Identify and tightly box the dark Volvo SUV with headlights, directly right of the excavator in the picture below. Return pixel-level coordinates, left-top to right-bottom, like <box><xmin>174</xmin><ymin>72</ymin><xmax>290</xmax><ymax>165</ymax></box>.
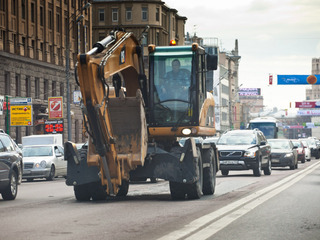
<box><xmin>217</xmin><ymin>129</ymin><xmax>271</xmax><ymax>176</ymax></box>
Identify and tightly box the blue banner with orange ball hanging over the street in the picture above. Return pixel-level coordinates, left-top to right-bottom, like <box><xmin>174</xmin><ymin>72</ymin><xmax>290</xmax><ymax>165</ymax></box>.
<box><xmin>278</xmin><ymin>74</ymin><xmax>320</xmax><ymax>85</ymax></box>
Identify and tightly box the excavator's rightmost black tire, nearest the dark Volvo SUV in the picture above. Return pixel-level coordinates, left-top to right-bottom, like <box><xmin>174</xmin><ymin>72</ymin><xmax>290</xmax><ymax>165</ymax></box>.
<box><xmin>202</xmin><ymin>148</ymin><xmax>217</xmax><ymax>195</ymax></box>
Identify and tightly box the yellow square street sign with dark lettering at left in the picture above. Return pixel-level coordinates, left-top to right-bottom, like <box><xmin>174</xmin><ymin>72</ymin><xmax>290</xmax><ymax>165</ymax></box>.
<box><xmin>10</xmin><ymin>105</ymin><xmax>33</xmax><ymax>126</ymax></box>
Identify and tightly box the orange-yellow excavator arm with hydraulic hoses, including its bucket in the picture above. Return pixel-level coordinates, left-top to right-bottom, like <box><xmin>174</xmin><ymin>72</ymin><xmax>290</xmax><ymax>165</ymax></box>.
<box><xmin>73</xmin><ymin>31</ymin><xmax>147</xmax><ymax>195</ymax></box>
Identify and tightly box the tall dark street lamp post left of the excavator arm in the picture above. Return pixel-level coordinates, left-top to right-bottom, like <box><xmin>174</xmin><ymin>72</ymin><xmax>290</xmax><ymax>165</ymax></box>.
<box><xmin>66</xmin><ymin>2</ymin><xmax>91</xmax><ymax>141</ymax></box>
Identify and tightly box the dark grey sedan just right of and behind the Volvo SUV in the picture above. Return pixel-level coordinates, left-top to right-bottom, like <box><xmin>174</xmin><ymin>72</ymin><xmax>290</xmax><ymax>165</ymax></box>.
<box><xmin>268</xmin><ymin>139</ymin><xmax>298</xmax><ymax>170</ymax></box>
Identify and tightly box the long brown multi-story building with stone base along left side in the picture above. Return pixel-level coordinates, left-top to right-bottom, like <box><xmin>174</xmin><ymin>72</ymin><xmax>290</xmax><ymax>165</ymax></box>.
<box><xmin>0</xmin><ymin>0</ymin><xmax>92</xmax><ymax>142</ymax></box>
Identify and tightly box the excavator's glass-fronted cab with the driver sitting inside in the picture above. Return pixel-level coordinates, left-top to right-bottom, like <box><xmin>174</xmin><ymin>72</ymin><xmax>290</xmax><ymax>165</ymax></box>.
<box><xmin>148</xmin><ymin>45</ymin><xmax>213</xmax><ymax>136</ymax></box>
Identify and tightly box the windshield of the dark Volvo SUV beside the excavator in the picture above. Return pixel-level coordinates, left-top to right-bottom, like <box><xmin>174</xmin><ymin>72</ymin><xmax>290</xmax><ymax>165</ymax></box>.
<box><xmin>217</xmin><ymin>134</ymin><xmax>256</xmax><ymax>145</ymax></box>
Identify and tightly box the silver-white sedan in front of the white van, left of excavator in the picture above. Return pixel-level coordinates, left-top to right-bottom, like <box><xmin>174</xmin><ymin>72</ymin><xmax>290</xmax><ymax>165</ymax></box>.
<box><xmin>22</xmin><ymin>145</ymin><xmax>67</xmax><ymax>181</ymax></box>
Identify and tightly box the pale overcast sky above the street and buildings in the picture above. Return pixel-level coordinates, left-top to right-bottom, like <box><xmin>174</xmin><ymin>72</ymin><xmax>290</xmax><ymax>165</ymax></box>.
<box><xmin>163</xmin><ymin>0</ymin><xmax>320</xmax><ymax>110</ymax></box>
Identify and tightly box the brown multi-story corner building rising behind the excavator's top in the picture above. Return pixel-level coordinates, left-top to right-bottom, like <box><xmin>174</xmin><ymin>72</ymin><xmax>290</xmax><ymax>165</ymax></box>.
<box><xmin>92</xmin><ymin>0</ymin><xmax>187</xmax><ymax>55</ymax></box>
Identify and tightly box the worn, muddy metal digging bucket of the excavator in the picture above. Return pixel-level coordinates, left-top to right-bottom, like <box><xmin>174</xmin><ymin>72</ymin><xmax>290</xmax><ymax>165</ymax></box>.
<box><xmin>108</xmin><ymin>90</ymin><xmax>148</xmax><ymax>170</ymax></box>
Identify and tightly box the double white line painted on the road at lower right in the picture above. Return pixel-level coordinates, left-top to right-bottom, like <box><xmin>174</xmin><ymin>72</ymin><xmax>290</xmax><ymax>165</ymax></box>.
<box><xmin>158</xmin><ymin>162</ymin><xmax>320</xmax><ymax>240</ymax></box>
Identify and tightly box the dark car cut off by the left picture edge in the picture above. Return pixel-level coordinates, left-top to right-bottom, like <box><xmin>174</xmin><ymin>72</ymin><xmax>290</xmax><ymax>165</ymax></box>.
<box><xmin>0</xmin><ymin>132</ymin><xmax>23</xmax><ymax>200</ymax></box>
